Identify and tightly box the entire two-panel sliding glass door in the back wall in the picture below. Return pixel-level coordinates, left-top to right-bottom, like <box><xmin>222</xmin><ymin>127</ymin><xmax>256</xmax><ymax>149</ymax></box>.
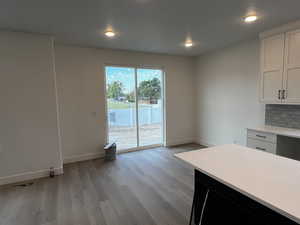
<box><xmin>105</xmin><ymin>66</ymin><xmax>164</xmax><ymax>151</ymax></box>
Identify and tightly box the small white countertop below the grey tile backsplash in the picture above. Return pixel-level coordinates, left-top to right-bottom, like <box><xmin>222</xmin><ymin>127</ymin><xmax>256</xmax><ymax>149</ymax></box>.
<box><xmin>248</xmin><ymin>126</ymin><xmax>300</xmax><ymax>138</ymax></box>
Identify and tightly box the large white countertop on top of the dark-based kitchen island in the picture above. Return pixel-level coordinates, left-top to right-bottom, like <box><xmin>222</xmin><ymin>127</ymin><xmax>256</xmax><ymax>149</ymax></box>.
<box><xmin>175</xmin><ymin>145</ymin><xmax>300</xmax><ymax>223</ymax></box>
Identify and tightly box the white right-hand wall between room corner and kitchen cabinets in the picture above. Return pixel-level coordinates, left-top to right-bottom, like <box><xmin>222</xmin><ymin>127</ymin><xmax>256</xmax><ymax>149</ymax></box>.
<box><xmin>197</xmin><ymin>40</ymin><xmax>264</xmax><ymax>145</ymax></box>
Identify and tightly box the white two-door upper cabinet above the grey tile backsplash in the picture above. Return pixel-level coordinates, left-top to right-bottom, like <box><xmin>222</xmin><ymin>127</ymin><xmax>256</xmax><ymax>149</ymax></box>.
<box><xmin>260</xmin><ymin>21</ymin><xmax>300</xmax><ymax>104</ymax></box>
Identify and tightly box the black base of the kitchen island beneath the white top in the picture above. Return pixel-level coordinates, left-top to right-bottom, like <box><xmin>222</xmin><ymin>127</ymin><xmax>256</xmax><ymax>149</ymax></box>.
<box><xmin>190</xmin><ymin>170</ymin><xmax>300</xmax><ymax>225</ymax></box>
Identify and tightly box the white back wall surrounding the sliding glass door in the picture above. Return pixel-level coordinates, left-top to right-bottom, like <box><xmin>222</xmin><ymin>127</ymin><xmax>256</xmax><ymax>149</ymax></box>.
<box><xmin>55</xmin><ymin>45</ymin><xmax>196</xmax><ymax>161</ymax></box>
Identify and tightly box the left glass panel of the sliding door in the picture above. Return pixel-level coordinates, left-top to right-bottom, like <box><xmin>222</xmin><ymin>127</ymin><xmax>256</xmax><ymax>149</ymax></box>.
<box><xmin>105</xmin><ymin>66</ymin><xmax>138</xmax><ymax>150</ymax></box>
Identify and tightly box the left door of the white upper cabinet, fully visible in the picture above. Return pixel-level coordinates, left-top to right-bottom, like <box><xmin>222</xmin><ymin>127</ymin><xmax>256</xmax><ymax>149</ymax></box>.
<box><xmin>261</xmin><ymin>34</ymin><xmax>284</xmax><ymax>103</ymax></box>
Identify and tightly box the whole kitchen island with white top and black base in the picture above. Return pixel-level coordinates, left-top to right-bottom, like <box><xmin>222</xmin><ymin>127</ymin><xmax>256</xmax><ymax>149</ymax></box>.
<box><xmin>175</xmin><ymin>145</ymin><xmax>300</xmax><ymax>225</ymax></box>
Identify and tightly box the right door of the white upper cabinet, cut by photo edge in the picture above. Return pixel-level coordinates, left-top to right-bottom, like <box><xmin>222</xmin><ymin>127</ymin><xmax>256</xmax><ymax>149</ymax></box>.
<box><xmin>283</xmin><ymin>30</ymin><xmax>300</xmax><ymax>103</ymax></box>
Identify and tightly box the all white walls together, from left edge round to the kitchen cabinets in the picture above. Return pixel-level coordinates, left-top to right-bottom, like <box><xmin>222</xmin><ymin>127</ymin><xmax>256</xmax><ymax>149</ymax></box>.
<box><xmin>0</xmin><ymin>32</ymin><xmax>264</xmax><ymax>184</ymax></box>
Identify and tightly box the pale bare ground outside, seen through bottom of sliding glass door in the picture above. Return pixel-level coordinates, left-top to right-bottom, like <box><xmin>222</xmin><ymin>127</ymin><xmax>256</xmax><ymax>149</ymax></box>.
<box><xmin>109</xmin><ymin>124</ymin><xmax>163</xmax><ymax>150</ymax></box>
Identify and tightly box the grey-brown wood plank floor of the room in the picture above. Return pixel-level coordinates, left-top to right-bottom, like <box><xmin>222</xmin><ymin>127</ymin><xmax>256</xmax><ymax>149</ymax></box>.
<box><xmin>0</xmin><ymin>145</ymin><xmax>201</xmax><ymax>225</ymax></box>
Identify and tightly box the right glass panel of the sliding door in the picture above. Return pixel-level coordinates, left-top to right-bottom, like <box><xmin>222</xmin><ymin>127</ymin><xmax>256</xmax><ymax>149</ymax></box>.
<box><xmin>137</xmin><ymin>69</ymin><xmax>163</xmax><ymax>146</ymax></box>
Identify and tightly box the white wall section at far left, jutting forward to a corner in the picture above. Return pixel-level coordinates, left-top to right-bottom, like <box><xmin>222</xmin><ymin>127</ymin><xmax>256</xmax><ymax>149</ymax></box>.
<box><xmin>0</xmin><ymin>32</ymin><xmax>62</xmax><ymax>184</ymax></box>
